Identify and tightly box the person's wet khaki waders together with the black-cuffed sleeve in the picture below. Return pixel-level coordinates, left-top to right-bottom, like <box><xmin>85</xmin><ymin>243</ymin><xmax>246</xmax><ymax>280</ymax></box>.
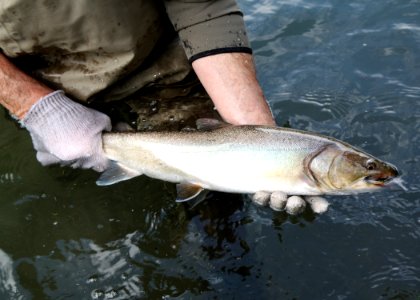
<box><xmin>0</xmin><ymin>0</ymin><xmax>250</xmax><ymax>101</ymax></box>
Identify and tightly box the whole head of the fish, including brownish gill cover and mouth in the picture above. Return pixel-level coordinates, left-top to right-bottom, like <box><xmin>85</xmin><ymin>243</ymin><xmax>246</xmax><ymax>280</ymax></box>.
<box><xmin>308</xmin><ymin>146</ymin><xmax>399</xmax><ymax>194</ymax></box>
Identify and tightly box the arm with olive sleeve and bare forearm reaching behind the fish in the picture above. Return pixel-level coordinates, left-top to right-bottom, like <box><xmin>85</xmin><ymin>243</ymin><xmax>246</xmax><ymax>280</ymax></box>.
<box><xmin>165</xmin><ymin>0</ymin><xmax>275</xmax><ymax>125</ymax></box>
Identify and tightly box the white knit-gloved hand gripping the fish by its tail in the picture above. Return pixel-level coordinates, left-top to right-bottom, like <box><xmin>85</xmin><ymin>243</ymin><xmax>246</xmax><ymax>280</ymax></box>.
<box><xmin>22</xmin><ymin>91</ymin><xmax>111</xmax><ymax>172</ymax></box>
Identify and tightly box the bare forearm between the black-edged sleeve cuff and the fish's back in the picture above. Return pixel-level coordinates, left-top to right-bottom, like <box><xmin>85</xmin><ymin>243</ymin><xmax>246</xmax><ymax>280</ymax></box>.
<box><xmin>192</xmin><ymin>53</ymin><xmax>275</xmax><ymax>125</ymax></box>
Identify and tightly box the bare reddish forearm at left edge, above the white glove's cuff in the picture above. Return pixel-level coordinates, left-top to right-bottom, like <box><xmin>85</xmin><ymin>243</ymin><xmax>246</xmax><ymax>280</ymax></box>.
<box><xmin>0</xmin><ymin>52</ymin><xmax>53</xmax><ymax>120</ymax></box>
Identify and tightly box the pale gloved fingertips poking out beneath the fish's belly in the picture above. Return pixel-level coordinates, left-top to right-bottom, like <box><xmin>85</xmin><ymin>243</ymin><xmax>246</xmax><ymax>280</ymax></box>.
<box><xmin>251</xmin><ymin>191</ymin><xmax>329</xmax><ymax>215</ymax></box>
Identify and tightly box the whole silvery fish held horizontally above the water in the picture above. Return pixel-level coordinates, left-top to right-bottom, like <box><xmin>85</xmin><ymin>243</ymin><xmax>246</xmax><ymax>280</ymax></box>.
<box><xmin>96</xmin><ymin>119</ymin><xmax>399</xmax><ymax>202</ymax></box>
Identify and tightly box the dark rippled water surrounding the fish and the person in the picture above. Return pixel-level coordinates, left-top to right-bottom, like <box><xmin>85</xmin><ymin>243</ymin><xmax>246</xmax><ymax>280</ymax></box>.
<box><xmin>0</xmin><ymin>0</ymin><xmax>420</xmax><ymax>299</ymax></box>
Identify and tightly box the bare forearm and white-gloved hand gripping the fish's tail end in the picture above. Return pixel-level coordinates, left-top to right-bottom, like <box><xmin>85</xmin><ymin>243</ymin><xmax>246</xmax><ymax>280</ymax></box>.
<box><xmin>0</xmin><ymin>53</ymin><xmax>111</xmax><ymax>171</ymax></box>
